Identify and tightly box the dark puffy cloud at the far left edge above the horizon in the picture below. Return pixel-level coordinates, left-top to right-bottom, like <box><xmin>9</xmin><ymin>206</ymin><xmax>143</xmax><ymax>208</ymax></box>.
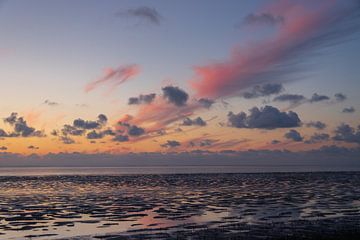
<box><xmin>1</xmin><ymin>112</ymin><xmax>45</xmax><ymax>137</ymax></box>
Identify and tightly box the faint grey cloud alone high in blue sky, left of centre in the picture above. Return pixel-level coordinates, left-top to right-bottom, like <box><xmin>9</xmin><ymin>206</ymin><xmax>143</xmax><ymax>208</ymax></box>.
<box><xmin>116</xmin><ymin>6</ymin><xmax>162</xmax><ymax>25</ymax></box>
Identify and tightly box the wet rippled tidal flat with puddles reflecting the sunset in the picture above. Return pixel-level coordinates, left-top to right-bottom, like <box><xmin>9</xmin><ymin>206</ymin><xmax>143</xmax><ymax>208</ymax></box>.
<box><xmin>0</xmin><ymin>172</ymin><xmax>360</xmax><ymax>240</ymax></box>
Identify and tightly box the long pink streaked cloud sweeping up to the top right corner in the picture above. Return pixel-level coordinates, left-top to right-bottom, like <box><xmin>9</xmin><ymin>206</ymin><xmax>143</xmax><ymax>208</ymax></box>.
<box><xmin>190</xmin><ymin>1</ymin><xmax>360</xmax><ymax>99</ymax></box>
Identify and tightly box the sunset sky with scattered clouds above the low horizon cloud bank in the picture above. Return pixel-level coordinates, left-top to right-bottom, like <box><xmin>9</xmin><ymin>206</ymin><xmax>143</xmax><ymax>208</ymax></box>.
<box><xmin>0</xmin><ymin>0</ymin><xmax>360</xmax><ymax>163</ymax></box>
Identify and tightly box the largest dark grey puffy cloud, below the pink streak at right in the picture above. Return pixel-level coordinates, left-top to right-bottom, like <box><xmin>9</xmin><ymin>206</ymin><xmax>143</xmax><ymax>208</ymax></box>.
<box><xmin>228</xmin><ymin>106</ymin><xmax>301</xmax><ymax>129</ymax></box>
